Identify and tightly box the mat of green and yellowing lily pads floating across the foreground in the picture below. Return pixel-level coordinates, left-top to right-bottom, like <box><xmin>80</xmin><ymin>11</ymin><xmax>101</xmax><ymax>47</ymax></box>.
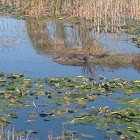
<box><xmin>0</xmin><ymin>72</ymin><xmax>140</xmax><ymax>139</ymax></box>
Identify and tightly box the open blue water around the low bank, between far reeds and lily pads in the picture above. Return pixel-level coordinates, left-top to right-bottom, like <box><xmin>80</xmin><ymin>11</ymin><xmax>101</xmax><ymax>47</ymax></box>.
<box><xmin>0</xmin><ymin>17</ymin><xmax>139</xmax><ymax>79</ymax></box>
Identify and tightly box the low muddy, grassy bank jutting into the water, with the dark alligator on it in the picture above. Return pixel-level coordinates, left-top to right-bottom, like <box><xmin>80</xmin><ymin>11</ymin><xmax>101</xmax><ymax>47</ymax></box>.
<box><xmin>53</xmin><ymin>53</ymin><xmax>140</xmax><ymax>70</ymax></box>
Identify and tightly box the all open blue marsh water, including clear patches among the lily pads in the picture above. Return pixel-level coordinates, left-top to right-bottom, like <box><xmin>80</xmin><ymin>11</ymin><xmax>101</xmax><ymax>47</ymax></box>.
<box><xmin>0</xmin><ymin>16</ymin><xmax>140</xmax><ymax>140</ymax></box>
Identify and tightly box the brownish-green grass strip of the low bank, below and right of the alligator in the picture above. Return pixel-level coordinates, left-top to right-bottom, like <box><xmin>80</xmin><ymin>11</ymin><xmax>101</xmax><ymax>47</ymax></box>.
<box><xmin>54</xmin><ymin>54</ymin><xmax>140</xmax><ymax>70</ymax></box>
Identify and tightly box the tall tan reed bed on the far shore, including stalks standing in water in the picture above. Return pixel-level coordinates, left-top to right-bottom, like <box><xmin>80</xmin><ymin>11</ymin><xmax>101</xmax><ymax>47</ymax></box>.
<box><xmin>0</xmin><ymin>0</ymin><xmax>140</xmax><ymax>34</ymax></box>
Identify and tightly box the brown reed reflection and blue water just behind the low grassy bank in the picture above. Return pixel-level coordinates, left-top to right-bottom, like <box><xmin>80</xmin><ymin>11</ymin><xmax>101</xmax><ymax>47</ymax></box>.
<box><xmin>26</xmin><ymin>20</ymin><xmax>140</xmax><ymax>54</ymax></box>
